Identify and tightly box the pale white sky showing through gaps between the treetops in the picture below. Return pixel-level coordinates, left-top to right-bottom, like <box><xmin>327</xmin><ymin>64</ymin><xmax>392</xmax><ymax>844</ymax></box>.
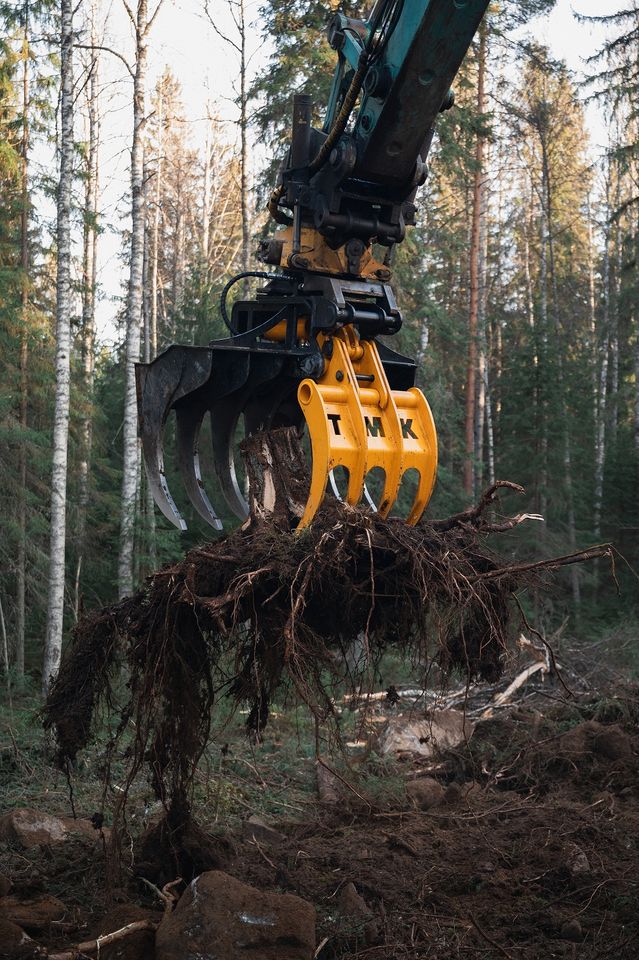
<box><xmin>90</xmin><ymin>0</ymin><xmax>624</xmax><ymax>341</ymax></box>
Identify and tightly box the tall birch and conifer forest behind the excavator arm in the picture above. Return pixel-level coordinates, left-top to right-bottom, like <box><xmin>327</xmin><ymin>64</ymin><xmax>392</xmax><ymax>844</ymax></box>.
<box><xmin>0</xmin><ymin>0</ymin><xmax>639</xmax><ymax>686</ymax></box>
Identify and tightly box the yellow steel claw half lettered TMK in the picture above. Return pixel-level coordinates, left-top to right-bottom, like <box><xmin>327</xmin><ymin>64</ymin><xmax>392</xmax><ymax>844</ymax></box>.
<box><xmin>297</xmin><ymin>326</ymin><xmax>437</xmax><ymax>529</ymax></box>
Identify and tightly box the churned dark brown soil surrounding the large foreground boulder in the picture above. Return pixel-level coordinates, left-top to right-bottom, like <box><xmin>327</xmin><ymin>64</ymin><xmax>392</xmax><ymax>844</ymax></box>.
<box><xmin>0</xmin><ymin>687</ymin><xmax>639</xmax><ymax>960</ymax></box>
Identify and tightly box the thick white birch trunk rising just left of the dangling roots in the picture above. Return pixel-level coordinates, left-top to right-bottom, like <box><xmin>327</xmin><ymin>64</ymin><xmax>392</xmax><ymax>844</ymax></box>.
<box><xmin>42</xmin><ymin>0</ymin><xmax>73</xmax><ymax>694</ymax></box>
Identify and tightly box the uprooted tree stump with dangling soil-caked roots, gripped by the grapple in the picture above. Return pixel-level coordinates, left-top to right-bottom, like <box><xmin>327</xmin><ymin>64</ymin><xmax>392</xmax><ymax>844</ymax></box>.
<box><xmin>44</xmin><ymin>430</ymin><xmax>608</xmax><ymax>834</ymax></box>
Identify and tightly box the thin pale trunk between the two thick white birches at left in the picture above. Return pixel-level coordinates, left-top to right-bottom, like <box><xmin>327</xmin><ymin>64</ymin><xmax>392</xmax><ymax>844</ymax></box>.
<box><xmin>74</xmin><ymin>30</ymin><xmax>100</xmax><ymax>620</ymax></box>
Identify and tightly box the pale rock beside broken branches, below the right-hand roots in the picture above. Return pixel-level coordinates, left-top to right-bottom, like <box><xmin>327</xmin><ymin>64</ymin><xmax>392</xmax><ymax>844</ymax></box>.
<box><xmin>376</xmin><ymin>710</ymin><xmax>475</xmax><ymax>757</ymax></box>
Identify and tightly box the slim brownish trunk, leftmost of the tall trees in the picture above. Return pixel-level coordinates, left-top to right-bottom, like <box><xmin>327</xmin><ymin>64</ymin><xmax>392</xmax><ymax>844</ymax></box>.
<box><xmin>14</xmin><ymin>11</ymin><xmax>30</xmax><ymax>683</ymax></box>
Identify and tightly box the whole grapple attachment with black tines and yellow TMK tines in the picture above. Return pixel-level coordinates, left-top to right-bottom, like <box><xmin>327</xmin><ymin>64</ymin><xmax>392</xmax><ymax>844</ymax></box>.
<box><xmin>136</xmin><ymin>277</ymin><xmax>437</xmax><ymax>530</ymax></box>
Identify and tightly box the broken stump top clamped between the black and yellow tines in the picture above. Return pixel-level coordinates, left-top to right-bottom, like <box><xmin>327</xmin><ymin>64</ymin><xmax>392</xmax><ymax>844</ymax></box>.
<box><xmin>240</xmin><ymin>427</ymin><xmax>310</xmax><ymax>531</ymax></box>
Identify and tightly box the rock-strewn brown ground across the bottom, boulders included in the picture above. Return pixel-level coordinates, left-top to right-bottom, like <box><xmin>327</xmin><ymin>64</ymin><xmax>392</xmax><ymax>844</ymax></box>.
<box><xmin>0</xmin><ymin>668</ymin><xmax>639</xmax><ymax>960</ymax></box>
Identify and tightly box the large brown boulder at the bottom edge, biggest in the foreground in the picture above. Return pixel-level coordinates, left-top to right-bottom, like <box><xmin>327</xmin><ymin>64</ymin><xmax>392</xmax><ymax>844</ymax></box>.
<box><xmin>155</xmin><ymin>870</ymin><xmax>315</xmax><ymax>960</ymax></box>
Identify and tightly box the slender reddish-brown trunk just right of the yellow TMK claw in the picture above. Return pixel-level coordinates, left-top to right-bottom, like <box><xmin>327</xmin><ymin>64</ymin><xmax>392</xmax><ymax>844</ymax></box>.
<box><xmin>464</xmin><ymin>23</ymin><xmax>486</xmax><ymax>497</ymax></box>
